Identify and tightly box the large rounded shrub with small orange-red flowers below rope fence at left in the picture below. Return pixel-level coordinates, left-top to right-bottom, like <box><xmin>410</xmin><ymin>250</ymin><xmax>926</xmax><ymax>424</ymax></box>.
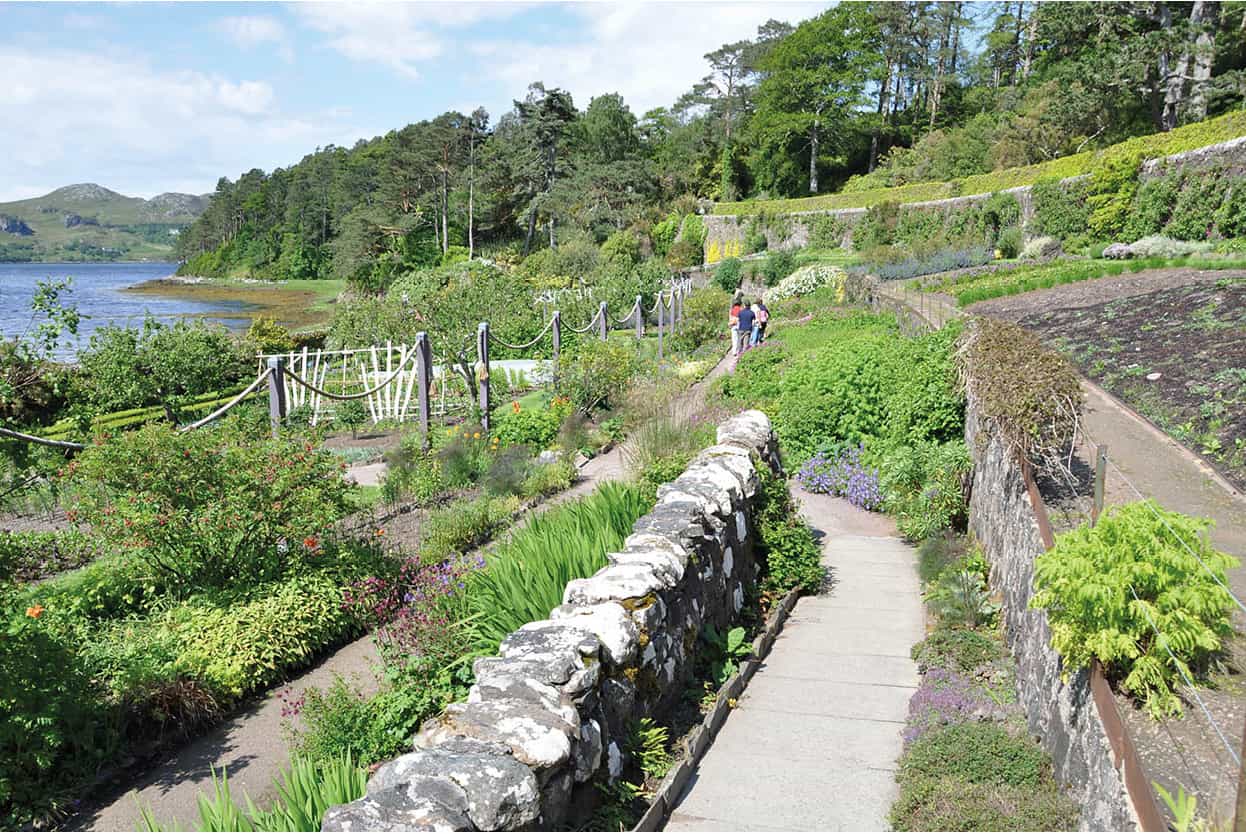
<box><xmin>66</xmin><ymin>423</ymin><xmax>350</xmax><ymax>592</ymax></box>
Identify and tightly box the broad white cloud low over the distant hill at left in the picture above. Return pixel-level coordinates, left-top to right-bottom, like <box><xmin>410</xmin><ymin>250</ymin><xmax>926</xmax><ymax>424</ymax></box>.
<box><xmin>0</xmin><ymin>45</ymin><xmax>361</xmax><ymax>198</ymax></box>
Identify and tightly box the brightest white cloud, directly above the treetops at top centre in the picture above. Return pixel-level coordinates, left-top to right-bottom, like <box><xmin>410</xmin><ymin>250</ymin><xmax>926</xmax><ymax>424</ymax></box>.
<box><xmin>473</xmin><ymin>0</ymin><xmax>831</xmax><ymax>115</ymax></box>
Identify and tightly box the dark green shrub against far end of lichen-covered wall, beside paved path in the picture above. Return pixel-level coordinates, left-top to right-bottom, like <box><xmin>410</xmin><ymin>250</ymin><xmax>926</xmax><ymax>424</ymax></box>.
<box><xmin>753</xmin><ymin>466</ymin><xmax>826</xmax><ymax>597</ymax></box>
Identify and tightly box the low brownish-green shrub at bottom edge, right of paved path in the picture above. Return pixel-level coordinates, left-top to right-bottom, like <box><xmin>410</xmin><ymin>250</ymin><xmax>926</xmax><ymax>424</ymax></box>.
<box><xmin>890</xmin><ymin>777</ymin><xmax>1078</xmax><ymax>832</ymax></box>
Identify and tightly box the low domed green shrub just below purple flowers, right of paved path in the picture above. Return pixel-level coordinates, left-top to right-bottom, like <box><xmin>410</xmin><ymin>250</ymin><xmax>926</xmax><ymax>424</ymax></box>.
<box><xmin>896</xmin><ymin>722</ymin><xmax>1052</xmax><ymax>788</ymax></box>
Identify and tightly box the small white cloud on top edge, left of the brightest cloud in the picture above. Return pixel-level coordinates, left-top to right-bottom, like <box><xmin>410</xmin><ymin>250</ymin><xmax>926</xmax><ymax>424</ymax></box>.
<box><xmin>294</xmin><ymin>2</ymin><xmax>526</xmax><ymax>80</ymax></box>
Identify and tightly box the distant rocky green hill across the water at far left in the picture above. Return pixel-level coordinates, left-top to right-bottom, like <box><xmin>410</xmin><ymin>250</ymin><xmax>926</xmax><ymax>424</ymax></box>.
<box><xmin>0</xmin><ymin>182</ymin><xmax>211</xmax><ymax>262</ymax></box>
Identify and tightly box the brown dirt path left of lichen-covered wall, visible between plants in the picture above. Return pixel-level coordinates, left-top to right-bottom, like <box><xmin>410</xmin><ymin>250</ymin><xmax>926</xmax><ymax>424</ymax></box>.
<box><xmin>75</xmin><ymin>357</ymin><xmax>735</xmax><ymax>832</ymax></box>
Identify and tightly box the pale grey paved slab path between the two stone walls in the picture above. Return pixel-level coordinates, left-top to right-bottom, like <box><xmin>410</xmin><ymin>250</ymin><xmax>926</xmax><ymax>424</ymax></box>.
<box><xmin>667</xmin><ymin>489</ymin><xmax>925</xmax><ymax>832</ymax></box>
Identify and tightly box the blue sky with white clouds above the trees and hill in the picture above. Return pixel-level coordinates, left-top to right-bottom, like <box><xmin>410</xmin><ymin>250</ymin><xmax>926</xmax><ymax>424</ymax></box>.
<box><xmin>0</xmin><ymin>0</ymin><xmax>831</xmax><ymax>202</ymax></box>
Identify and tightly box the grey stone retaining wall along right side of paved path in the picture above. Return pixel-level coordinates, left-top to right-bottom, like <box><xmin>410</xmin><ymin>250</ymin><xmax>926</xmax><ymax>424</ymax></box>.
<box><xmin>964</xmin><ymin>404</ymin><xmax>1139</xmax><ymax>832</ymax></box>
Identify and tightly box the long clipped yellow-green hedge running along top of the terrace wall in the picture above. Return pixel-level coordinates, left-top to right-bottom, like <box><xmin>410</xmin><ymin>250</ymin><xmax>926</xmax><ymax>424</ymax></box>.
<box><xmin>714</xmin><ymin>112</ymin><xmax>1246</xmax><ymax>214</ymax></box>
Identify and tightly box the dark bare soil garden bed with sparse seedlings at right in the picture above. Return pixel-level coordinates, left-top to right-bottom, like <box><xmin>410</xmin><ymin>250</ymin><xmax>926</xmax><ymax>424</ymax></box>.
<box><xmin>971</xmin><ymin>269</ymin><xmax>1246</xmax><ymax>490</ymax></box>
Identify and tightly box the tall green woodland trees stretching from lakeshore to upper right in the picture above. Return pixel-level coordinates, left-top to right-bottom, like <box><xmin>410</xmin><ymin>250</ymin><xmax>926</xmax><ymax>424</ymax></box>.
<box><xmin>178</xmin><ymin>0</ymin><xmax>1246</xmax><ymax>289</ymax></box>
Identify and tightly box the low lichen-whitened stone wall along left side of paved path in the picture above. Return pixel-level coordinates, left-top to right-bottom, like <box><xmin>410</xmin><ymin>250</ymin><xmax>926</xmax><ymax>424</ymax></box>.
<box><xmin>323</xmin><ymin>411</ymin><xmax>779</xmax><ymax>832</ymax></box>
